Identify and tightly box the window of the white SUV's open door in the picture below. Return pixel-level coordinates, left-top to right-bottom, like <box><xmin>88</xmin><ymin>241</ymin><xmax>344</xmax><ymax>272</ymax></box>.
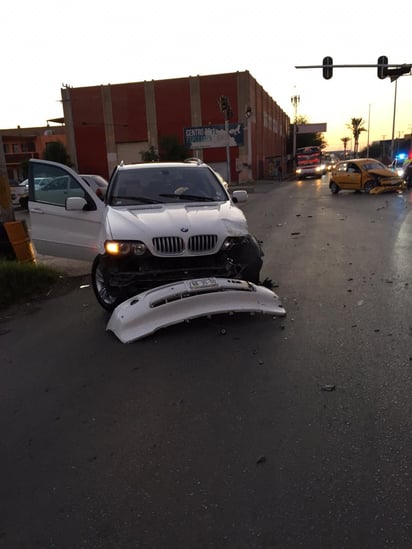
<box><xmin>32</xmin><ymin>164</ymin><xmax>88</xmax><ymax>208</ymax></box>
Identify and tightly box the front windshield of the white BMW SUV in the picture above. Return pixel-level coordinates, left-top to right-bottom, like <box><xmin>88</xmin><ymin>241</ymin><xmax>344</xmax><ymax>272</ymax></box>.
<box><xmin>108</xmin><ymin>166</ymin><xmax>228</xmax><ymax>206</ymax></box>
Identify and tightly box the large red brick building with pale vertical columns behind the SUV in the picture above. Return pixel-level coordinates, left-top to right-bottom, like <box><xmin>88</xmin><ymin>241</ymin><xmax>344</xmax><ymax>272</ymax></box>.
<box><xmin>61</xmin><ymin>71</ymin><xmax>290</xmax><ymax>182</ymax></box>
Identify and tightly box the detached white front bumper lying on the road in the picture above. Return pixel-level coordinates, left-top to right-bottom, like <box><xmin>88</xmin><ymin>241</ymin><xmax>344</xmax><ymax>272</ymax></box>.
<box><xmin>106</xmin><ymin>278</ymin><xmax>286</xmax><ymax>343</ymax></box>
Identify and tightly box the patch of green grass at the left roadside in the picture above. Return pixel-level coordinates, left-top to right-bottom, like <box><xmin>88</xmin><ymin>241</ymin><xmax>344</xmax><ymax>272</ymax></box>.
<box><xmin>0</xmin><ymin>260</ymin><xmax>60</xmax><ymax>307</ymax></box>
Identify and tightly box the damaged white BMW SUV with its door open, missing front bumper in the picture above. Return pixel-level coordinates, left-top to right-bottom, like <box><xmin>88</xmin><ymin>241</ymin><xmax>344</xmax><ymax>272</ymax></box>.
<box><xmin>29</xmin><ymin>160</ymin><xmax>263</xmax><ymax>311</ymax></box>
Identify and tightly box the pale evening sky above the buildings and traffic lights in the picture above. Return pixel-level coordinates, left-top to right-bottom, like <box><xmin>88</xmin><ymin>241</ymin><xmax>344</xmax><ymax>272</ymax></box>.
<box><xmin>0</xmin><ymin>0</ymin><xmax>412</xmax><ymax>150</ymax></box>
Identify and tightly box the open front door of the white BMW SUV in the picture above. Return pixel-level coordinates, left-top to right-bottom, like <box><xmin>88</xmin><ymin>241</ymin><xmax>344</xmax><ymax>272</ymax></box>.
<box><xmin>29</xmin><ymin>160</ymin><xmax>105</xmax><ymax>261</ymax></box>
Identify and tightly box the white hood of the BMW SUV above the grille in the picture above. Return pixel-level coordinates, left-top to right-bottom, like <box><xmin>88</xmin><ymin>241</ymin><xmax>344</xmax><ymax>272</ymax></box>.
<box><xmin>105</xmin><ymin>202</ymin><xmax>248</xmax><ymax>241</ymax></box>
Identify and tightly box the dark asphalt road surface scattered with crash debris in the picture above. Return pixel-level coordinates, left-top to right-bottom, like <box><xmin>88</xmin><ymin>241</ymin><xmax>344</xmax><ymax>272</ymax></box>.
<box><xmin>0</xmin><ymin>180</ymin><xmax>412</xmax><ymax>549</ymax></box>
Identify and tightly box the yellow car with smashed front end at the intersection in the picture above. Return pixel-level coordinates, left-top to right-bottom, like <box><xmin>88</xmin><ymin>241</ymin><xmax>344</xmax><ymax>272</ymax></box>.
<box><xmin>329</xmin><ymin>158</ymin><xmax>406</xmax><ymax>194</ymax></box>
